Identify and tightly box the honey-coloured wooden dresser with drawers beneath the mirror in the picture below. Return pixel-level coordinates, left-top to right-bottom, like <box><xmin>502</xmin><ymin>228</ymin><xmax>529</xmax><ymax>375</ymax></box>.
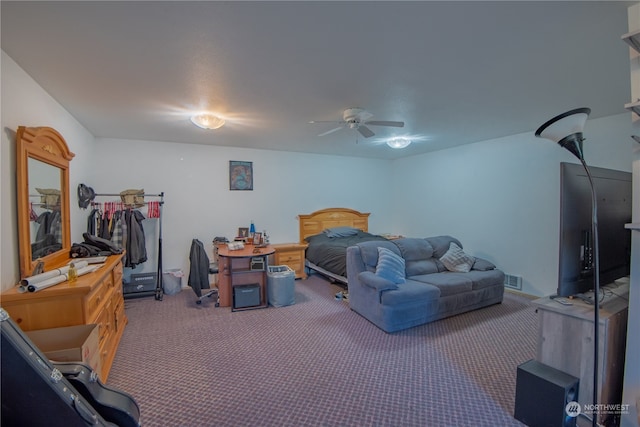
<box><xmin>0</xmin><ymin>255</ymin><xmax>127</xmax><ymax>382</ymax></box>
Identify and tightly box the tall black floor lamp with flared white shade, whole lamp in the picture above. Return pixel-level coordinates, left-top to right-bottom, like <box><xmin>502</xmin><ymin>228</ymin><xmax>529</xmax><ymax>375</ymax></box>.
<box><xmin>536</xmin><ymin>108</ymin><xmax>600</xmax><ymax>427</ymax></box>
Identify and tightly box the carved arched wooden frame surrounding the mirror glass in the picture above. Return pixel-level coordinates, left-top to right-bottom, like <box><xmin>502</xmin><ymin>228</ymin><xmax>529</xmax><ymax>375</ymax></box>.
<box><xmin>16</xmin><ymin>126</ymin><xmax>75</xmax><ymax>278</ymax></box>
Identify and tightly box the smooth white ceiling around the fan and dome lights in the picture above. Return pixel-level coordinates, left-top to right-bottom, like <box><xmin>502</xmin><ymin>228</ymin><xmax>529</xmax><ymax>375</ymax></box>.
<box><xmin>0</xmin><ymin>1</ymin><xmax>634</xmax><ymax>159</ymax></box>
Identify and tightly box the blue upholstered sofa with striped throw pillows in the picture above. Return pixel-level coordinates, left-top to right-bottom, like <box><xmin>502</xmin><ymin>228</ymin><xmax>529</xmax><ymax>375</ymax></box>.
<box><xmin>347</xmin><ymin>236</ymin><xmax>504</xmax><ymax>333</ymax></box>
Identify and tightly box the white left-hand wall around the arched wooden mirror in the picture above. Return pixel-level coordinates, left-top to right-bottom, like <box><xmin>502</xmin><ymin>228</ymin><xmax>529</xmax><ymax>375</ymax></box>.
<box><xmin>0</xmin><ymin>51</ymin><xmax>94</xmax><ymax>289</ymax></box>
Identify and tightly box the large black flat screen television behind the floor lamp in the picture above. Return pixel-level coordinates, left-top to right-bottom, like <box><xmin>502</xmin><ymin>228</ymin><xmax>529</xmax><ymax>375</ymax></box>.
<box><xmin>558</xmin><ymin>163</ymin><xmax>632</xmax><ymax>297</ymax></box>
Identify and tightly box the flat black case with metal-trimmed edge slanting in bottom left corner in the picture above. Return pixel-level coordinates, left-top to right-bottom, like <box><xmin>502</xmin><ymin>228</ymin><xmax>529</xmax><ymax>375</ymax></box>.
<box><xmin>0</xmin><ymin>308</ymin><xmax>115</xmax><ymax>427</ymax></box>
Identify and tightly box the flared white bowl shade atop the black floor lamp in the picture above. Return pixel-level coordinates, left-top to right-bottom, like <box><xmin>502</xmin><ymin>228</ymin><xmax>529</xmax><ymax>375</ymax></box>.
<box><xmin>536</xmin><ymin>108</ymin><xmax>591</xmax><ymax>158</ymax></box>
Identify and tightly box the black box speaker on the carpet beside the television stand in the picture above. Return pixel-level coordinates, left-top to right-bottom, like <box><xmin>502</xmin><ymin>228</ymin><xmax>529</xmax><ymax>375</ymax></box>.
<box><xmin>514</xmin><ymin>360</ymin><xmax>580</xmax><ymax>427</ymax></box>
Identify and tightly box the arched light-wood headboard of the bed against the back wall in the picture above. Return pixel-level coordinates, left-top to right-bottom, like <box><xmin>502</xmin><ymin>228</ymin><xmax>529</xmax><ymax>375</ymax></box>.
<box><xmin>298</xmin><ymin>208</ymin><xmax>370</xmax><ymax>243</ymax></box>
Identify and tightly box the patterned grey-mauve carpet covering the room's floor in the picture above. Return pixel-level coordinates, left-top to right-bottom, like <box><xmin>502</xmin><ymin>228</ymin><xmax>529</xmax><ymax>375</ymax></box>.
<box><xmin>108</xmin><ymin>275</ymin><xmax>537</xmax><ymax>427</ymax></box>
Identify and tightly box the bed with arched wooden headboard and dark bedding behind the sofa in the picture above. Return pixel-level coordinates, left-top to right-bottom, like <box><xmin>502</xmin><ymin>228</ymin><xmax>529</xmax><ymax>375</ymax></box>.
<box><xmin>298</xmin><ymin>208</ymin><xmax>387</xmax><ymax>285</ymax></box>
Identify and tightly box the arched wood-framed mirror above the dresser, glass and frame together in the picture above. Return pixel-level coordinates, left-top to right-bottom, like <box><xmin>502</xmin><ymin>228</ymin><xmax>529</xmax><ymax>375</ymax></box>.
<box><xmin>16</xmin><ymin>126</ymin><xmax>74</xmax><ymax>278</ymax></box>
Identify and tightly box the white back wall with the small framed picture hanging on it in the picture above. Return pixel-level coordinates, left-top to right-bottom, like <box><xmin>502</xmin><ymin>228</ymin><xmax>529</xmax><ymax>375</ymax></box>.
<box><xmin>86</xmin><ymin>139</ymin><xmax>393</xmax><ymax>284</ymax></box>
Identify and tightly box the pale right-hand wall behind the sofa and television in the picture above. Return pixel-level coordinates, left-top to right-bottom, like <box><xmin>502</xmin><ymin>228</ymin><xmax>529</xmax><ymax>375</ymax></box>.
<box><xmin>392</xmin><ymin>115</ymin><xmax>635</xmax><ymax>296</ymax></box>
